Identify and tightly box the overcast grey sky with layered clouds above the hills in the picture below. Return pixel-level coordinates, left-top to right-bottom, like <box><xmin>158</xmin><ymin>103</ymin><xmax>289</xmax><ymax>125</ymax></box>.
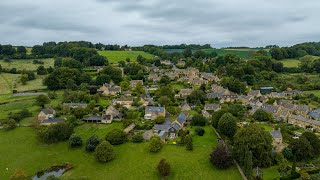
<box><xmin>0</xmin><ymin>0</ymin><xmax>320</xmax><ymax>47</ymax></box>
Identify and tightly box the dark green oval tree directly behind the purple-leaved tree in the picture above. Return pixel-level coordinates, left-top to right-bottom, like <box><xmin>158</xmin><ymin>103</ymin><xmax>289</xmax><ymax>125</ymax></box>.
<box><xmin>218</xmin><ymin>113</ymin><xmax>237</xmax><ymax>138</ymax></box>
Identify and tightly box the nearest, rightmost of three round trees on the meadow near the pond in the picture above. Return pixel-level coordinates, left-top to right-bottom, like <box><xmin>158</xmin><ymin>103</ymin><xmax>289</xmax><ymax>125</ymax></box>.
<box><xmin>94</xmin><ymin>141</ymin><xmax>115</xmax><ymax>163</ymax></box>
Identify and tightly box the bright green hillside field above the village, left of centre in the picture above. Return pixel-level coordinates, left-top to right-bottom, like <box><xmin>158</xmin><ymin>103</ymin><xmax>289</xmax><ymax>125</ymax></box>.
<box><xmin>98</xmin><ymin>51</ymin><xmax>154</xmax><ymax>63</ymax></box>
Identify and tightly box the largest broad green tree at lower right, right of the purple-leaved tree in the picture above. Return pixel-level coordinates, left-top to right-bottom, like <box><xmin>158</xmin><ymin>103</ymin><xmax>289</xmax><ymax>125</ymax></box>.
<box><xmin>233</xmin><ymin>124</ymin><xmax>272</xmax><ymax>167</ymax></box>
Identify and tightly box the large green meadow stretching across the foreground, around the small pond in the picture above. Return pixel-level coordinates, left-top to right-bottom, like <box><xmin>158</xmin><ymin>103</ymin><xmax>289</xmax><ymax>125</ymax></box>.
<box><xmin>0</xmin><ymin>123</ymin><xmax>241</xmax><ymax>180</ymax></box>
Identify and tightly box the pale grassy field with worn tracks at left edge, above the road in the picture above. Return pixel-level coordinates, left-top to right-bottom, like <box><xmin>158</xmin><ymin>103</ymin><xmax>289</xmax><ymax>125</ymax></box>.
<box><xmin>0</xmin><ymin>73</ymin><xmax>46</xmax><ymax>95</ymax></box>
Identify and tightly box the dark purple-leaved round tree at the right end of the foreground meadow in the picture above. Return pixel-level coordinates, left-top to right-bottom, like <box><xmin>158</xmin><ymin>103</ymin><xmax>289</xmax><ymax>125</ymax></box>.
<box><xmin>210</xmin><ymin>144</ymin><xmax>233</xmax><ymax>169</ymax></box>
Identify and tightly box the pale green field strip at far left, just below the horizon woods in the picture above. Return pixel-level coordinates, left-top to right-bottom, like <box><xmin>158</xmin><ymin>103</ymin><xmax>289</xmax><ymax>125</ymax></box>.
<box><xmin>0</xmin><ymin>58</ymin><xmax>54</xmax><ymax>71</ymax></box>
